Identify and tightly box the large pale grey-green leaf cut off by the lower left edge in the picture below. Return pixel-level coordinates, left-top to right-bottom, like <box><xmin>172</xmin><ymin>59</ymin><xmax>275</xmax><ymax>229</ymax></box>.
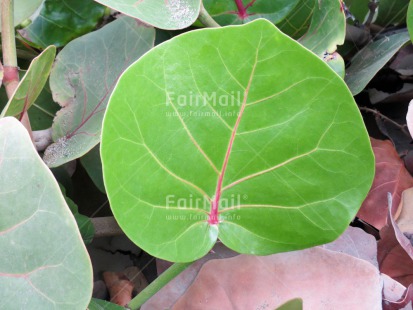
<box><xmin>0</xmin><ymin>117</ymin><xmax>92</xmax><ymax>310</ymax></box>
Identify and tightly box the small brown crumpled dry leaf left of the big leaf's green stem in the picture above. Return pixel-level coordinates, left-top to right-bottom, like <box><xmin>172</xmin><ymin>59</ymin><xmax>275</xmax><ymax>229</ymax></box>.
<box><xmin>103</xmin><ymin>271</ymin><xmax>134</xmax><ymax>306</ymax></box>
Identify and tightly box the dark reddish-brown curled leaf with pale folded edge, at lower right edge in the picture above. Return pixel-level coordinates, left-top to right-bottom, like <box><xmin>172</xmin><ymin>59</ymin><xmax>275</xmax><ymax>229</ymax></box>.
<box><xmin>377</xmin><ymin>202</ymin><xmax>413</xmax><ymax>286</ymax></box>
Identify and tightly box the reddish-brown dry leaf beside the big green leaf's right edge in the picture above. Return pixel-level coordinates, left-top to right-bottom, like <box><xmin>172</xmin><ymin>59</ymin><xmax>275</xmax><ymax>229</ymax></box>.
<box><xmin>357</xmin><ymin>138</ymin><xmax>413</xmax><ymax>229</ymax></box>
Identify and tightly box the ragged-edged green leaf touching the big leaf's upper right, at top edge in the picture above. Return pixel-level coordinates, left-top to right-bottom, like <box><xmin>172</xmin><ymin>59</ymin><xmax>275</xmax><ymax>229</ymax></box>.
<box><xmin>300</xmin><ymin>0</ymin><xmax>346</xmax><ymax>57</ymax></box>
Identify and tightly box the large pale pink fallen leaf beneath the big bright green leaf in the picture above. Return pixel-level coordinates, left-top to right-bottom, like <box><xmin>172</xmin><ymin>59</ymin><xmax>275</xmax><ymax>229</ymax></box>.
<box><xmin>173</xmin><ymin>247</ymin><xmax>382</xmax><ymax>310</ymax></box>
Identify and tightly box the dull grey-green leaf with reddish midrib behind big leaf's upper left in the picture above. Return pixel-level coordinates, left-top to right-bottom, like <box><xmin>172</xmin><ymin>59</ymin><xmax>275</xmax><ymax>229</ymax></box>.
<box><xmin>43</xmin><ymin>17</ymin><xmax>155</xmax><ymax>167</ymax></box>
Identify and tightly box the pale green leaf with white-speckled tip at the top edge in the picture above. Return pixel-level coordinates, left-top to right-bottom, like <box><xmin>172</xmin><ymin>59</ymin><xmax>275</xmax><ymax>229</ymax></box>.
<box><xmin>95</xmin><ymin>0</ymin><xmax>201</xmax><ymax>30</ymax></box>
